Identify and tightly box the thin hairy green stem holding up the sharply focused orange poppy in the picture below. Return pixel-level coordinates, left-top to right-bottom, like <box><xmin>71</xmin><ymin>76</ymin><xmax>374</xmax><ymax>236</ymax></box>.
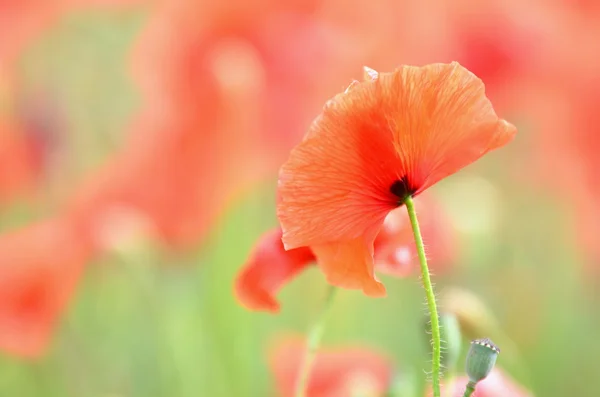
<box><xmin>404</xmin><ymin>196</ymin><xmax>441</xmax><ymax>397</ymax></box>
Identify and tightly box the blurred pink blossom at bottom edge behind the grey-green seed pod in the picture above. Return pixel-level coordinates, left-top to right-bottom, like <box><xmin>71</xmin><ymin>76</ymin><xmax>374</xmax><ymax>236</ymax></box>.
<box><xmin>427</xmin><ymin>368</ymin><xmax>533</xmax><ymax>397</ymax></box>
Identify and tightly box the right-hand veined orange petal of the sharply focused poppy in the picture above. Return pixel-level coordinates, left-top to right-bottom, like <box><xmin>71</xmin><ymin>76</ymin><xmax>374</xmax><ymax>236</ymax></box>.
<box><xmin>386</xmin><ymin>62</ymin><xmax>517</xmax><ymax>194</ymax></box>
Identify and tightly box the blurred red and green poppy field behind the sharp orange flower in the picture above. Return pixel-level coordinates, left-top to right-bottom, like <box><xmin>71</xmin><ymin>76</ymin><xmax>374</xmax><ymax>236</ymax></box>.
<box><xmin>0</xmin><ymin>0</ymin><xmax>600</xmax><ymax>397</ymax></box>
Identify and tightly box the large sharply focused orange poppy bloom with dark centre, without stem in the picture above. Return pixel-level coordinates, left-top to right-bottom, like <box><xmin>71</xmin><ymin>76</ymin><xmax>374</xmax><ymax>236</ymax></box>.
<box><xmin>277</xmin><ymin>63</ymin><xmax>516</xmax><ymax>296</ymax></box>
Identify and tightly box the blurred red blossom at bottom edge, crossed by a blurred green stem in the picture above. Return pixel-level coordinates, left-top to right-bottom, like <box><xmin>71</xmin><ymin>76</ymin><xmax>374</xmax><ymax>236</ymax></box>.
<box><xmin>269</xmin><ymin>338</ymin><xmax>393</xmax><ymax>397</ymax></box>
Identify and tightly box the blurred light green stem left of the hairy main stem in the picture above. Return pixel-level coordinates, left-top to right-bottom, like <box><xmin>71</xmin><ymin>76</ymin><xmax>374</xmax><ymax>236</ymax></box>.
<box><xmin>294</xmin><ymin>285</ymin><xmax>337</xmax><ymax>397</ymax></box>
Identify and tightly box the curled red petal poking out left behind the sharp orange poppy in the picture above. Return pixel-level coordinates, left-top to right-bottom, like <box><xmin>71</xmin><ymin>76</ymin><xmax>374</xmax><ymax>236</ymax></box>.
<box><xmin>235</xmin><ymin>228</ymin><xmax>315</xmax><ymax>313</ymax></box>
